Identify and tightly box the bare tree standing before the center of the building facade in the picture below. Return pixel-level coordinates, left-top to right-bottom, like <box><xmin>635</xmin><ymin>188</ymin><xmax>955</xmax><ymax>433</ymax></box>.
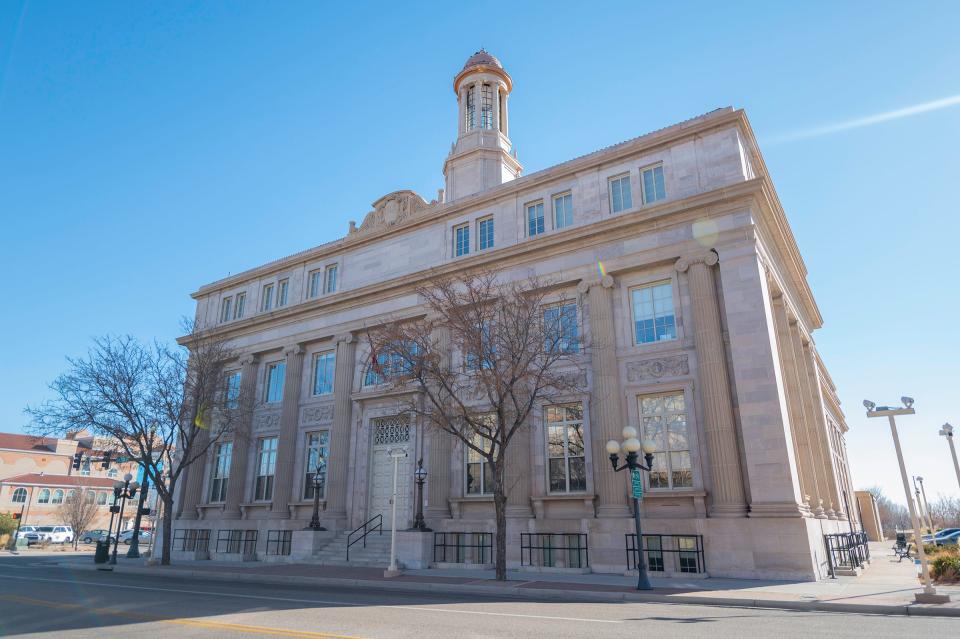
<box><xmin>367</xmin><ymin>271</ymin><xmax>585</xmax><ymax>580</ymax></box>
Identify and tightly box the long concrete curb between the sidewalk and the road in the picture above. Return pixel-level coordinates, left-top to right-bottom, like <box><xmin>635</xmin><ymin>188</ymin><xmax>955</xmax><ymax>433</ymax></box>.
<box><xmin>57</xmin><ymin>563</ymin><xmax>960</xmax><ymax>617</ymax></box>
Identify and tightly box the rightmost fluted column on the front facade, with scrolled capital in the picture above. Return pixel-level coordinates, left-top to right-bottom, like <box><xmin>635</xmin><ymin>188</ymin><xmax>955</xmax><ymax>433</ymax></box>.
<box><xmin>677</xmin><ymin>251</ymin><xmax>746</xmax><ymax>517</ymax></box>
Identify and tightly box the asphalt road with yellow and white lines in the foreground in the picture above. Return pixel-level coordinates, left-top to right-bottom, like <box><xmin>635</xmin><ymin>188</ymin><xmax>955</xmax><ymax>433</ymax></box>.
<box><xmin>0</xmin><ymin>553</ymin><xmax>960</xmax><ymax>639</ymax></box>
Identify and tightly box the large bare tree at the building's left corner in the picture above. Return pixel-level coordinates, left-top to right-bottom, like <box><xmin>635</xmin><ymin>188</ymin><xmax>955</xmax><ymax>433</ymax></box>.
<box><xmin>26</xmin><ymin>326</ymin><xmax>248</xmax><ymax>565</ymax></box>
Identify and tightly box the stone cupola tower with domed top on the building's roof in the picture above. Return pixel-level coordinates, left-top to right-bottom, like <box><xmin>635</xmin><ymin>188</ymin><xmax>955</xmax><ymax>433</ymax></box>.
<box><xmin>443</xmin><ymin>49</ymin><xmax>523</xmax><ymax>202</ymax></box>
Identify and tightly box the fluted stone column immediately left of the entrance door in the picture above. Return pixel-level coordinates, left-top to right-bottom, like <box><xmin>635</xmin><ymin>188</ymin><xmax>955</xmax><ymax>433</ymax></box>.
<box><xmin>327</xmin><ymin>333</ymin><xmax>357</xmax><ymax>519</ymax></box>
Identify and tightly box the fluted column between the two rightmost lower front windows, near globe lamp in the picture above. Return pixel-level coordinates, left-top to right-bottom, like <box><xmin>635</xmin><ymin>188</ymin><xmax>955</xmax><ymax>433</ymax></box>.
<box><xmin>577</xmin><ymin>275</ymin><xmax>630</xmax><ymax>517</ymax></box>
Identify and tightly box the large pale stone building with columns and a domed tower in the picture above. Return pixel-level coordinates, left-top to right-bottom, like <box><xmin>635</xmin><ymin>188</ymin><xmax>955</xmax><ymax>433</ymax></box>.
<box><xmin>174</xmin><ymin>51</ymin><xmax>853</xmax><ymax>579</ymax></box>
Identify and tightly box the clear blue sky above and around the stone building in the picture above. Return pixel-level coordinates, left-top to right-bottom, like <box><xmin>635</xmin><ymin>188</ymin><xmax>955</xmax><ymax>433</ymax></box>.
<box><xmin>0</xmin><ymin>0</ymin><xmax>960</xmax><ymax>508</ymax></box>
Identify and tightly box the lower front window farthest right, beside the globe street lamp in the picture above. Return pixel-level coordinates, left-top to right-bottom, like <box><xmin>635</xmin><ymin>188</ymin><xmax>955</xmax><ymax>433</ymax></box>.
<box><xmin>638</xmin><ymin>391</ymin><xmax>693</xmax><ymax>488</ymax></box>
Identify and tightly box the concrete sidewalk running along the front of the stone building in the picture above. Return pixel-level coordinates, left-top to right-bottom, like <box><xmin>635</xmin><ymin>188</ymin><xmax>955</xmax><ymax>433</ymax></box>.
<box><xmin>59</xmin><ymin>545</ymin><xmax>960</xmax><ymax>617</ymax></box>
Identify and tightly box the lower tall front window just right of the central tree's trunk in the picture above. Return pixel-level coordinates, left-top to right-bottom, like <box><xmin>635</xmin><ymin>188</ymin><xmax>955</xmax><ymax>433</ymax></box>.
<box><xmin>545</xmin><ymin>402</ymin><xmax>587</xmax><ymax>493</ymax></box>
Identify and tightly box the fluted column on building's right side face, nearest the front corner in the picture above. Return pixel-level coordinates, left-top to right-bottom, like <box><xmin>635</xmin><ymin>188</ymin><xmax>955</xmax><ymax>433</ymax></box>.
<box><xmin>771</xmin><ymin>294</ymin><xmax>817</xmax><ymax>509</ymax></box>
